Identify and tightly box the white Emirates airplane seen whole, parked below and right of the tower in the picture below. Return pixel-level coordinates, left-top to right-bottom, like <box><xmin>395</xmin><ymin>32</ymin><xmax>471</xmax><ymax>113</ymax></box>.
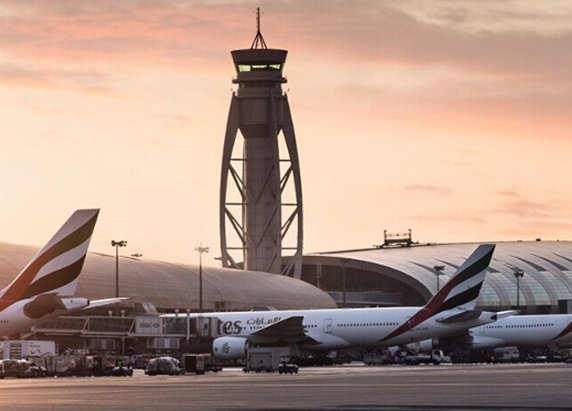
<box><xmin>167</xmin><ymin>244</ymin><xmax>502</xmax><ymax>360</ymax></box>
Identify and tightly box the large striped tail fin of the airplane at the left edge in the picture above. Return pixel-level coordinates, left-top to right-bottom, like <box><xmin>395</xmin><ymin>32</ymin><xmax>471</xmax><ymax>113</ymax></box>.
<box><xmin>1</xmin><ymin>209</ymin><xmax>99</xmax><ymax>306</ymax></box>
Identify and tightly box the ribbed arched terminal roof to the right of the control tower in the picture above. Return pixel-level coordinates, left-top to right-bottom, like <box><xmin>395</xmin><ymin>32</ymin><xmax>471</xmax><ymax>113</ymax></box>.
<box><xmin>303</xmin><ymin>241</ymin><xmax>572</xmax><ymax>311</ymax></box>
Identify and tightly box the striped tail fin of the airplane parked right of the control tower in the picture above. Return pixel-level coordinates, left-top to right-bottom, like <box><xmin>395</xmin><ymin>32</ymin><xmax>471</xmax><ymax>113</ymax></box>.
<box><xmin>425</xmin><ymin>244</ymin><xmax>495</xmax><ymax>313</ymax></box>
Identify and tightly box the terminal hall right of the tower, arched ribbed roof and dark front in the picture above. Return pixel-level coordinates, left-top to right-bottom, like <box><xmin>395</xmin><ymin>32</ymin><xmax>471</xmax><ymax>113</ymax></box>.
<box><xmin>302</xmin><ymin>241</ymin><xmax>572</xmax><ymax>314</ymax></box>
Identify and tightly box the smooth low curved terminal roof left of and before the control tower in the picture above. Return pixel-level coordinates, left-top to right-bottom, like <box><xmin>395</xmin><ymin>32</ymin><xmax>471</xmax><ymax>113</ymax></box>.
<box><xmin>0</xmin><ymin>243</ymin><xmax>336</xmax><ymax>312</ymax></box>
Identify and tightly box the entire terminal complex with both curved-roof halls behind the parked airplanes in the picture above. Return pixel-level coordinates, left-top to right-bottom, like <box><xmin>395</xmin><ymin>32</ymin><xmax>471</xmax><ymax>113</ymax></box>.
<box><xmin>0</xmin><ymin>241</ymin><xmax>572</xmax><ymax>313</ymax></box>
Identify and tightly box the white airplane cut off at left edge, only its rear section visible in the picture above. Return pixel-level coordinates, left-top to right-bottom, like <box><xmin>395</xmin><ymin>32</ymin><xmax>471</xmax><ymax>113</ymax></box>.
<box><xmin>0</xmin><ymin>209</ymin><xmax>123</xmax><ymax>337</ymax></box>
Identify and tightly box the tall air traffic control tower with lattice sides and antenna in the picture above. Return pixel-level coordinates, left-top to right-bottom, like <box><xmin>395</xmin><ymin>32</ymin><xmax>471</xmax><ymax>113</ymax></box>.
<box><xmin>219</xmin><ymin>11</ymin><xmax>303</xmax><ymax>278</ymax></box>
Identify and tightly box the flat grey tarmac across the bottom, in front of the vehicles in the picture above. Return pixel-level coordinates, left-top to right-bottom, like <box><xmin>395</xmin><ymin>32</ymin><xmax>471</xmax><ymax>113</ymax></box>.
<box><xmin>0</xmin><ymin>363</ymin><xmax>572</xmax><ymax>411</ymax></box>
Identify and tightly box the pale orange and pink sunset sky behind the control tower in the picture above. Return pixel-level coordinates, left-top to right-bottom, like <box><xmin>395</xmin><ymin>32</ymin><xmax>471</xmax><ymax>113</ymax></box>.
<box><xmin>0</xmin><ymin>0</ymin><xmax>572</xmax><ymax>265</ymax></box>
